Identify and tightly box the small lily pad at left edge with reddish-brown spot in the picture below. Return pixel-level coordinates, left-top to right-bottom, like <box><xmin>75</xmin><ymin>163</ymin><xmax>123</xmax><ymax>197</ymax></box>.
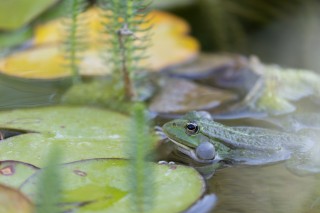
<box><xmin>0</xmin><ymin>161</ymin><xmax>38</xmax><ymax>189</ymax></box>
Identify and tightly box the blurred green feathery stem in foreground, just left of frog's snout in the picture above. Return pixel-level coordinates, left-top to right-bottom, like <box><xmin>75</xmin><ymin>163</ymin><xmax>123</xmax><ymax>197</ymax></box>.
<box><xmin>128</xmin><ymin>104</ymin><xmax>154</xmax><ymax>213</ymax></box>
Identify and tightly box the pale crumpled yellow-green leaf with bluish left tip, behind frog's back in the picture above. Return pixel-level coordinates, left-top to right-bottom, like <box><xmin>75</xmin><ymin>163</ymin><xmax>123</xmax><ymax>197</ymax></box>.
<box><xmin>211</xmin><ymin>58</ymin><xmax>320</xmax><ymax>119</ymax></box>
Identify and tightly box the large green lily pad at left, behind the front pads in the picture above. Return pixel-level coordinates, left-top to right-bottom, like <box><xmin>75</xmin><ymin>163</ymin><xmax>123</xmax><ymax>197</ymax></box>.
<box><xmin>0</xmin><ymin>106</ymin><xmax>135</xmax><ymax>167</ymax></box>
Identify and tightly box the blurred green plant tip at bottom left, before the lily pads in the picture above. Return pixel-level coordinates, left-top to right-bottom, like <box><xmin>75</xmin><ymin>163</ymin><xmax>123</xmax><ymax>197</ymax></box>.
<box><xmin>35</xmin><ymin>147</ymin><xmax>62</xmax><ymax>213</ymax></box>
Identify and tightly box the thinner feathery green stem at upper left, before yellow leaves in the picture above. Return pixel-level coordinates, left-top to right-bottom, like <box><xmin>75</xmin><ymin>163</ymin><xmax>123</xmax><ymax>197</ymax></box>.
<box><xmin>63</xmin><ymin>0</ymin><xmax>88</xmax><ymax>83</ymax></box>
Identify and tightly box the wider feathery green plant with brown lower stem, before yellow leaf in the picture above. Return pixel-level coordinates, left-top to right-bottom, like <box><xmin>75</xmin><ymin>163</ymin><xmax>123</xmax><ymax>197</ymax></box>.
<box><xmin>100</xmin><ymin>0</ymin><xmax>151</xmax><ymax>100</ymax></box>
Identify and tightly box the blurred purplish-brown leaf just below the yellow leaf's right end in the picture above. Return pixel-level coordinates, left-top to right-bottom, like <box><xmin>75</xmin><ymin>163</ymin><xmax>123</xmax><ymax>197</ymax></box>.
<box><xmin>170</xmin><ymin>53</ymin><xmax>261</xmax><ymax>96</ymax></box>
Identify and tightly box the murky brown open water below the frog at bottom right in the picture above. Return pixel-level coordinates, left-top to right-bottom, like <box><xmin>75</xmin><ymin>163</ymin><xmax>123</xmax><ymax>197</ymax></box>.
<box><xmin>208</xmin><ymin>164</ymin><xmax>320</xmax><ymax>213</ymax></box>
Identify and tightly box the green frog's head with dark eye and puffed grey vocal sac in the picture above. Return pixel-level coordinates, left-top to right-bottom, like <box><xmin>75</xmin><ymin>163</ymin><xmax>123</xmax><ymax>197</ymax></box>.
<box><xmin>162</xmin><ymin>112</ymin><xmax>217</xmax><ymax>163</ymax></box>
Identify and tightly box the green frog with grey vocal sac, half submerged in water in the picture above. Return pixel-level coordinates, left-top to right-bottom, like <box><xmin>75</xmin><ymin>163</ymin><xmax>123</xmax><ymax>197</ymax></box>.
<box><xmin>162</xmin><ymin>111</ymin><xmax>320</xmax><ymax>173</ymax></box>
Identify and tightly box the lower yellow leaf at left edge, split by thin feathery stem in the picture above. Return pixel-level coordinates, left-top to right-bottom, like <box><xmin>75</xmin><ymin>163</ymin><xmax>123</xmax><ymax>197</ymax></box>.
<box><xmin>0</xmin><ymin>45</ymin><xmax>110</xmax><ymax>79</ymax></box>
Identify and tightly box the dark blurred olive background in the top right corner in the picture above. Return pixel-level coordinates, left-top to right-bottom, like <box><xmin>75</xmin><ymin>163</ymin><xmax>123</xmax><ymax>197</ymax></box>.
<box><xmin>168</xmin><ymin>0</ymin><xmax>320</xmax><ymax>72</ymax></box>
